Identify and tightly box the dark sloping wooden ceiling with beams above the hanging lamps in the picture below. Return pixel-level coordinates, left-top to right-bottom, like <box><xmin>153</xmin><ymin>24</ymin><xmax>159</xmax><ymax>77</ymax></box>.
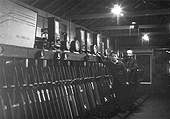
<box><xmin>16</xmin><ymin>0</ymin><xmax>170</xmax><ymax>37</ymax></box>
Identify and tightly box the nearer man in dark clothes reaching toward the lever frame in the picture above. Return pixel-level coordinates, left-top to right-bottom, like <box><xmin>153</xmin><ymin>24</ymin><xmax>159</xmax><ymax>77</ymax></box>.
<box><xmin>105</xmin><ymin>52</ymin><xmax>127</xmax><ymax>112</ymax></box>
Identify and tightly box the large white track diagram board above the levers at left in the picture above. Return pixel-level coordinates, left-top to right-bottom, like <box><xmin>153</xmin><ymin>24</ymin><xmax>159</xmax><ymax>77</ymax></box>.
<box><xmin>0</xmin><ymin>0</ymin><xmax>37</xmax><ymax>48</ymax></box>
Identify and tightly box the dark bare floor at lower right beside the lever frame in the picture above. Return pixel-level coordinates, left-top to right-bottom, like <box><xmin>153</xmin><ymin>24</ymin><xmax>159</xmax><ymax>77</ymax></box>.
<box><xmin>112</xmin><ymin>91</ymin><xmax>170</xmax><ymax>119</ymax></box>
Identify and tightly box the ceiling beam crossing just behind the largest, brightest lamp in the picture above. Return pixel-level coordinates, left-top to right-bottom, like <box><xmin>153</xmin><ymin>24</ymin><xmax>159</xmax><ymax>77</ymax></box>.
<box><xmin>65</xmin><ymin>9</ymin><xmax>170</xmax><ymax>20</ymax></box>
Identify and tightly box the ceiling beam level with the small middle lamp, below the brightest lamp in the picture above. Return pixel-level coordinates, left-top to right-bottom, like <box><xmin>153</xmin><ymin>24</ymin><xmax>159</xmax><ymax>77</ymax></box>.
<box><xmin>90</xmin><ymin>24</ymin><xmax>169</xmax><ymax>31</ymax></box>
